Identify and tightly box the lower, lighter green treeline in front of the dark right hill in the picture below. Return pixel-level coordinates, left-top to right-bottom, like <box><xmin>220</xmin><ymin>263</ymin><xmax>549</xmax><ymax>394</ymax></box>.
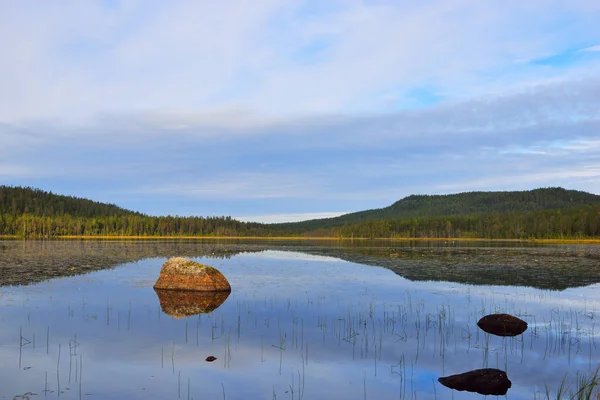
<box><xmin>296</xmin><ymin>206</ymin><xmax>600</xmax><ymax>239</ymax></box>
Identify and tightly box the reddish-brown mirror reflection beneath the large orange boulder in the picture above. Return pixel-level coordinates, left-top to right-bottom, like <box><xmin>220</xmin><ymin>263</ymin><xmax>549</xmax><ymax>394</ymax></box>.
<box><xmin>154</xmin><ymin>289</ymin><xmax>229</xmax><ymax>318</ymax></box>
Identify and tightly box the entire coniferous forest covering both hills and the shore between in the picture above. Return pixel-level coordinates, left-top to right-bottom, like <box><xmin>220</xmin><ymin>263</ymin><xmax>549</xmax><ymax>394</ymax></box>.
<box><xmin>0</xmin><ymin>186</ymin><xmax>600</xmax><ymax>239</ymax></box>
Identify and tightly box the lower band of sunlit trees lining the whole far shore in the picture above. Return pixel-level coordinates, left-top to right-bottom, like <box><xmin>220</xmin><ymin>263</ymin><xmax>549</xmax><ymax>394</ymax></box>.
<box><xmin>0</xmin><ymin>206</ymin><xmax>600</xmax><ymax>239</ymax></box>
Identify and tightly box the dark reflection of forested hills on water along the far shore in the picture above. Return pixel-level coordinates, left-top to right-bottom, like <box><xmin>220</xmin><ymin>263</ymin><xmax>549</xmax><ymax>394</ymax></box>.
<box><xmin>0</xmin><ymin>240</ymin><xmax>600</xmax><ymax>290</ymax></box>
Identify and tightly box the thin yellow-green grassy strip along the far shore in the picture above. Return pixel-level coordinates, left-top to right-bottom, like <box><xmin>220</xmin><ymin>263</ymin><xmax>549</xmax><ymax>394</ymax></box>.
<box><xmin>0</xmin><ymin>235</ymin><xmax>600</xmax><ymax>244</ymax></box>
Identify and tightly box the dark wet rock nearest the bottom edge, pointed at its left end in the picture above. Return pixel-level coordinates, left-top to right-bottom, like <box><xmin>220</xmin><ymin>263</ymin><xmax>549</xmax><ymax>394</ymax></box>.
<box><xmin>438</xmin><ymin>368</ymin><xmax>512</xmax><ymax>396</ymax></box>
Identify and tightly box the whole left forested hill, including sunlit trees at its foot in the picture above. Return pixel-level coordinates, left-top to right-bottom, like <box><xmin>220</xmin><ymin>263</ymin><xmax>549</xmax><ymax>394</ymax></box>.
<box><xmin>0</xmin><ymin>186</ymin><xmax>275</xmax><ymax>238</ymax></box>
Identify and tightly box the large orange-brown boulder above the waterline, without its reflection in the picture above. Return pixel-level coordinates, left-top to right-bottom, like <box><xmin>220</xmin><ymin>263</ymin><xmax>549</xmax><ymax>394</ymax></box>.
<box><xmin>154</xmin><ymin>257</ymin><xmax>231</xmax><ymax>292</ymax></box>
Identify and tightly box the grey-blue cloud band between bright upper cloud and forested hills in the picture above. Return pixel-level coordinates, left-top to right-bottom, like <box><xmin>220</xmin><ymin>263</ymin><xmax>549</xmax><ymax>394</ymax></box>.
<box><xmin>0</xmin><ymin>73</ymin><xmax>600</xmax><ymax>214</ymax></box>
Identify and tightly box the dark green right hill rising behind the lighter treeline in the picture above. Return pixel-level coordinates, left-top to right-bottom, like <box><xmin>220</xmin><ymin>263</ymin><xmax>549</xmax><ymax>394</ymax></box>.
<box><xmin>277</xmin><ymin>187</ymin><xmax>600</xmax><ymax>231</ymax></box>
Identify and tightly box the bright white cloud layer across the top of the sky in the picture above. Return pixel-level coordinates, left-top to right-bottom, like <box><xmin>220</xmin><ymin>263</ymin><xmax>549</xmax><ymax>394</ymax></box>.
<box><xmin>0</xmin><ymin>0</ymin><xmax>600</xmax><ymax>122</ymax></box>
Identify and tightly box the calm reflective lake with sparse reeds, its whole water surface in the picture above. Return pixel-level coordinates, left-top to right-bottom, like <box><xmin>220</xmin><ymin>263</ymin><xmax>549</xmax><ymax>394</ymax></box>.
<box><xmin>0</xmin><ymin>240</ymin><xmax>600</xmax><ymax>399</ymax></box>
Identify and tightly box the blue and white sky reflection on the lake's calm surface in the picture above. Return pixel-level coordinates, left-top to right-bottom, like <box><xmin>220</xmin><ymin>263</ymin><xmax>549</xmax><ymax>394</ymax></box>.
<box><xmin>0</xmin><ymin>248</ymin><xmax>600</xmax><ymax>400</ymax></box>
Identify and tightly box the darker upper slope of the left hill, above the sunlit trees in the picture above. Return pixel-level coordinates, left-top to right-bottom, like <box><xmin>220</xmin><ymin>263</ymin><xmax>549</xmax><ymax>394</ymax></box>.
<box><xmin>0</xmin><ymin>186</ymin><xmax>141</xmax><ymax>218</ymax></box>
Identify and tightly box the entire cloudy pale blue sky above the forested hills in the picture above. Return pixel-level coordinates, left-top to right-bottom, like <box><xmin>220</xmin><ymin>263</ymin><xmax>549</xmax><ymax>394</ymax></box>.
<box><xmin>0</xmin><ymin>0</ymin><xmax>600</xmax><ymax>222</ymax></box>
